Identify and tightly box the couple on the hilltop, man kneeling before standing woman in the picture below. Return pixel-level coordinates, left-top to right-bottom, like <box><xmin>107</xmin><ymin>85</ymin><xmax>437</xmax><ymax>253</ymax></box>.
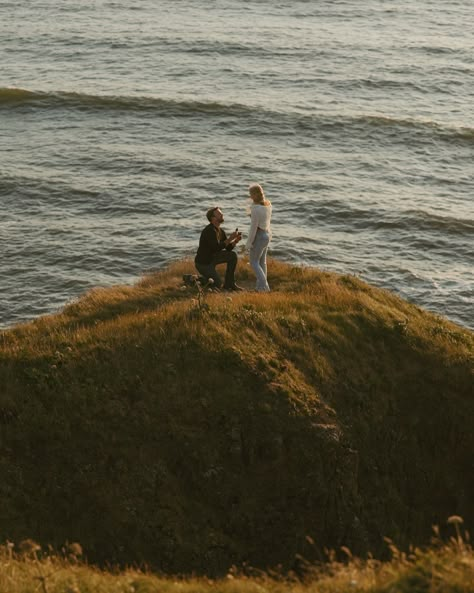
<box><xmin>194</xmin><ymin>184</ymin><xmax>272</xmax><ymax>292</ymax></box>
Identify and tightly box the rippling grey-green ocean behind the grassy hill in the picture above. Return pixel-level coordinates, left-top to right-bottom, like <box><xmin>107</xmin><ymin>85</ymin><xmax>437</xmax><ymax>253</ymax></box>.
<box><xmin>0</xmin><ymin>0</ymin><xmax>474</xmax><ymax>328</ymax></box>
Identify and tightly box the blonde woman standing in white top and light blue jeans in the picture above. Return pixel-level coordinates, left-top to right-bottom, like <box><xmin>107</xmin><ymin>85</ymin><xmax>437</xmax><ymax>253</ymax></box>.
<box><xmin>245</xmin><ymin>184</ymin><xmax>272</xmax><ymax>292</ymax></box>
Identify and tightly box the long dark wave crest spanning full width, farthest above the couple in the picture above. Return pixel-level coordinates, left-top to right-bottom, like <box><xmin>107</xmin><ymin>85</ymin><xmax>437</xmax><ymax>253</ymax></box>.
<box><xmin>0</xmin><ymin>87</ymin><xmax>474</xmax><ymax>143</ymax></box>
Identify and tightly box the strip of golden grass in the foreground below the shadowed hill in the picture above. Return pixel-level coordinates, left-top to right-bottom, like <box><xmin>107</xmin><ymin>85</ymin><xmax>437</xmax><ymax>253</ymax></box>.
<box><xmin>0</xmin><ymin>537</ymin><xmax>474</xmax><ymax>593</ymax></box>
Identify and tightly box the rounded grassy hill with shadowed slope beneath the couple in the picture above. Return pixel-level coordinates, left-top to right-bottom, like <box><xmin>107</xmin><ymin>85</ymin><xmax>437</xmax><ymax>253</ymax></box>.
<box><xmin>0</xmin><ymin>261</ymin><xmax>474</xmax><ymax>575</ymax></box>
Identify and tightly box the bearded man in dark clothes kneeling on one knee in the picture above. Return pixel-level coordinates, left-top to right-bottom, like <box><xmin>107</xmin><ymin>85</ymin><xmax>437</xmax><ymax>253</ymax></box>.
<box><xmin>194</xmin><ymin>207</ymin><xmax>242</xmax><ymax>290</ymax></box>
